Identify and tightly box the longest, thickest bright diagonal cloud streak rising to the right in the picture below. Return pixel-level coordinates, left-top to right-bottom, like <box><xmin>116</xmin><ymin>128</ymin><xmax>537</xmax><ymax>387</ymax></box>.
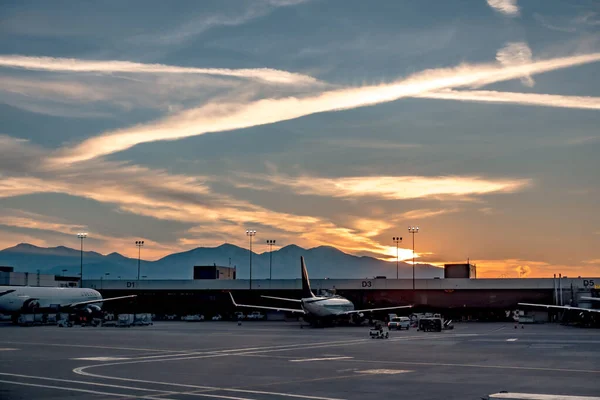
<box><xmin>49</xmin><ymin>53</ymin><xmax>600</xmax><ymax>163</ymax></box>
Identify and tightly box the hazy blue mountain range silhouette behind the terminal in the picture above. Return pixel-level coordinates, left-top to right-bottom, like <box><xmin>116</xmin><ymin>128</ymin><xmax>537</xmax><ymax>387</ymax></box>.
<box><xmin>0</xmin><ymin>243</ymin><xmax>443</xmax><ymax>279</ymax></box>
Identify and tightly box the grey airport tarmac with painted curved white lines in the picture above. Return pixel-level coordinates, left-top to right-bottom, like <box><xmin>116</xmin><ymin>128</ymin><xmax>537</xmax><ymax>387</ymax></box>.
<box><xmin>0</xmin><ymin>321</ymin><xmax>600</xmax><ymax>400</ymax></box>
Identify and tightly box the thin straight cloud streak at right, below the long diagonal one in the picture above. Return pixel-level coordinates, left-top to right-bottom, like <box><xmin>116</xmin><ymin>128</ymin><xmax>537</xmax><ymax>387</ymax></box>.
<box><xmin>413</xmin><ymin>89</ymin><xmax>600</xmax><ymax>110</ymax></box>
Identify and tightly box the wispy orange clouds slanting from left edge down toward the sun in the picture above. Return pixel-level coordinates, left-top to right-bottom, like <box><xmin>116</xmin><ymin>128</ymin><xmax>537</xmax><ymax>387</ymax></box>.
<box><xmin>0</xmin><ymin>139</ymin><xmax>412</xmax><ymax>254</ymax></box>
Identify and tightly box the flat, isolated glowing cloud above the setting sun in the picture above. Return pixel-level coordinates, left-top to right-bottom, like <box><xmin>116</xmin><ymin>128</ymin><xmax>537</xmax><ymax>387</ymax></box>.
<box><xmin>233</xmin><ymin>174</ymin><xmax>531</xmax><ymax>200</ymax></box>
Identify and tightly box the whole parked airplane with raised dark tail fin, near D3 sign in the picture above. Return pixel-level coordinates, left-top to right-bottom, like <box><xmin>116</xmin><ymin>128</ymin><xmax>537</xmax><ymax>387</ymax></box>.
<box><xmin>229</xmin><ymin>256</ymin><xmax>412</xmax><ymax>325</ymax></box>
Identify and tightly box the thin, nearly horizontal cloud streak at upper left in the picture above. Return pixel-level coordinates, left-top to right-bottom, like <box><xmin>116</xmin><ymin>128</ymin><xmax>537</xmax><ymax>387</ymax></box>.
<box><xmin>0</xmin><ymin>55</ymin><xmax>318</xmax><ymax>85</ymax></box>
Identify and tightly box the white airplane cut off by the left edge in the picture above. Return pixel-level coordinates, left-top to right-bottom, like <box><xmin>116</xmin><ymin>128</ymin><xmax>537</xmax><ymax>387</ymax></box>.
<box><xmin>0</xmin><ymin>286</ymin><xmax>136</xmax><ymax>322</ymax></box>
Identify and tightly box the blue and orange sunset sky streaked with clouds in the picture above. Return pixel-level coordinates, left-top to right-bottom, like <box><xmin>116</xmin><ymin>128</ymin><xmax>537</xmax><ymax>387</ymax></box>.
<box><xmin>0</xmin><ymin>0</ymin><xmax>600</xmax><ymax>278</ymax></box>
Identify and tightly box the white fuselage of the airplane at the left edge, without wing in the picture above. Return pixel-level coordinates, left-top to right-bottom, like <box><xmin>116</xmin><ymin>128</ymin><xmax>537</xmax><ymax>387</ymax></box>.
<box><xmin>0</xmin><ymin>286</ymin><xmax>102</xmax><ymax>314</ymax></box>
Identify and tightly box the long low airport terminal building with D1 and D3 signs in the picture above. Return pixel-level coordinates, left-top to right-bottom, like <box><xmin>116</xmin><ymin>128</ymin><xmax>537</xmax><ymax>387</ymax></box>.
<box><xmin>84</xmin><ymin>264</ymin><xmax>600</xmax><ymax>318</ymax></box>
